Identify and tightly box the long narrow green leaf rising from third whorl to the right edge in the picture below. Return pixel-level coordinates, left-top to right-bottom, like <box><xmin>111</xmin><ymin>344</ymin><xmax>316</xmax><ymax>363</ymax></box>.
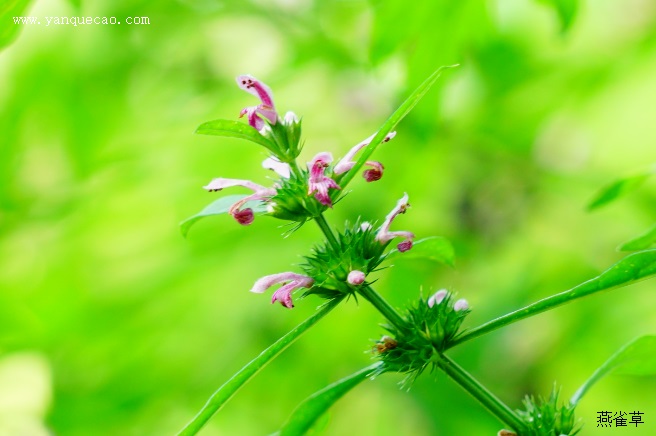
<box><xmin>451</xmin><ymin>249</ymin><xmax>656</xmax><ymax>346</ymax></box>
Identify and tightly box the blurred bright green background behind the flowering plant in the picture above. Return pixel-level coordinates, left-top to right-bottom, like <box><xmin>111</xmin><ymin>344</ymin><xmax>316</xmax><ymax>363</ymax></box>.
<box><xmin>0</xmin><ymin>0</ymin><xmax>656</xmax><ymax>436</ymax></box>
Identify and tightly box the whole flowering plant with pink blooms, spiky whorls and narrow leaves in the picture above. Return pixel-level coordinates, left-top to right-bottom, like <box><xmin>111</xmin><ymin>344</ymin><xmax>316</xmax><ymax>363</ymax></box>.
<box><xmin>180</xmin><ymin>67</ymin><xmax>656</xmax><ymax>436</ymax></box>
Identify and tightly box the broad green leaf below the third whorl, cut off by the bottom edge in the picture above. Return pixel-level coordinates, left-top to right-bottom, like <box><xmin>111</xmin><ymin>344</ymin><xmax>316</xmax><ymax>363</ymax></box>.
<box><xmin>278</xmin><ymin>362</ymin><xmax>380</xmax><ymax>436</ymax></box>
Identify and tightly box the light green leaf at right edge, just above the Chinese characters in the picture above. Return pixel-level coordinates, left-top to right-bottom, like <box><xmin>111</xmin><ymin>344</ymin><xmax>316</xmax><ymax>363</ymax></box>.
<box><xmin>570</xmin><ymin>335</ymin><xmax>656</xmax><ymax>405</ymax></box>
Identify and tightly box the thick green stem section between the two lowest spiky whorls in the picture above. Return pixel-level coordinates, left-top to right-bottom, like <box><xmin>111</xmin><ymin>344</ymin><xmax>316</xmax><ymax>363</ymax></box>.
<box><xmin>437</xmin><ymin>354</ymin><xmax>525</xmax><ymax>434</ymax></box>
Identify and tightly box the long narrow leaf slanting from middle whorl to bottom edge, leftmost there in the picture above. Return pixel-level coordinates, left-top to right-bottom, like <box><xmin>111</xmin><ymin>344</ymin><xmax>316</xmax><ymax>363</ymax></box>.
<box><xmin>178</xmin><ymin>298</ymin><xmax>341</xmax><ymax>436</ymax></box>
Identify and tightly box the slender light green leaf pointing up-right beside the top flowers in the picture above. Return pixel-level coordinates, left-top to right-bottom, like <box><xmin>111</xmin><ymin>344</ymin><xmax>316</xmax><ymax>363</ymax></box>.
<box><xmin>337</xmin><ymin>65</ymin><xmax>458</xmax><ymax>192</ymax></box>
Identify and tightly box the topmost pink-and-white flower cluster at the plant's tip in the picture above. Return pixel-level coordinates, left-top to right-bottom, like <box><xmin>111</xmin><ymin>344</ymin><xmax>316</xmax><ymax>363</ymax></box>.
<box><xmin>204</xmin><ymin>75</ymin><xmax>396</xmax><ymax>225</ymax></box>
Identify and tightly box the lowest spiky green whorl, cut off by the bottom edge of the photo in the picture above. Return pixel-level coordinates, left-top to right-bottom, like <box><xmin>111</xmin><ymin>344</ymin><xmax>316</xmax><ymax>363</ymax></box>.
<box><xmin>518</xmin><ymin>386</ymin><xmax>581</xmax><ymax>436</ymax></box>
